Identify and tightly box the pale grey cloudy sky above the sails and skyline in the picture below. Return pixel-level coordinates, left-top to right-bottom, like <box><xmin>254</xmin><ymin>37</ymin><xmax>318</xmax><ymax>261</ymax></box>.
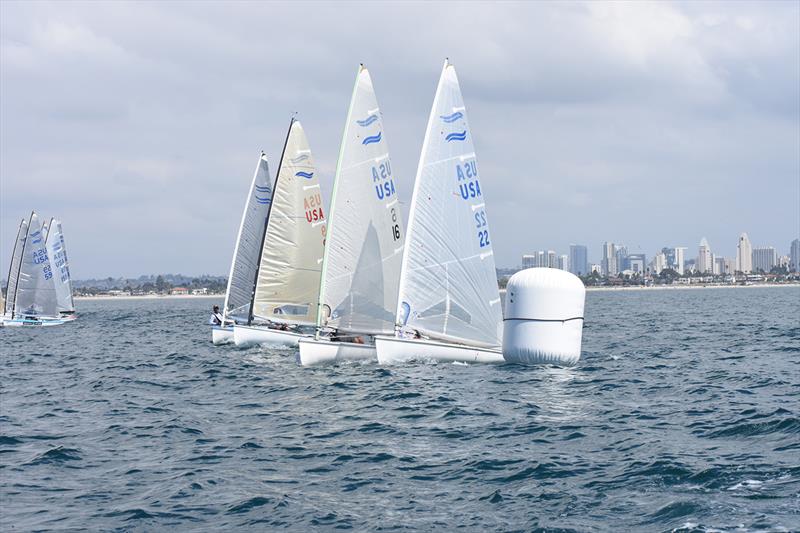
<box><xmin>0</xmin><ymin>0</ymin><xmax>800</xmax><ymax>279</ymax></box>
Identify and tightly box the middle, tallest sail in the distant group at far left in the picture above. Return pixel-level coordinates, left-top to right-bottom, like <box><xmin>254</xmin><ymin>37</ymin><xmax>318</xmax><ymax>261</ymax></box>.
<box><xmin>14</xmin><ymin>213</ymin><xmax>58</xmax><ymax>317</ymax></box>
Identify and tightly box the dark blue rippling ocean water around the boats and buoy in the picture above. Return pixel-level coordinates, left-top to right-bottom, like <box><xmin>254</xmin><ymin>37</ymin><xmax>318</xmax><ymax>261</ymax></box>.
<box><xmin>0</xmin><ymin>288</ymin><xmax>800</xmax><ymax>531</ymax></box>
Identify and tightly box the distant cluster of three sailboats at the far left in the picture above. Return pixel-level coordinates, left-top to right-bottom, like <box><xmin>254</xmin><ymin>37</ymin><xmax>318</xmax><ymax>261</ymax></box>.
<box><xmin>0</xmin><ymin>212</ymin><xmax>76</xmax><ymax>327</ymax></box>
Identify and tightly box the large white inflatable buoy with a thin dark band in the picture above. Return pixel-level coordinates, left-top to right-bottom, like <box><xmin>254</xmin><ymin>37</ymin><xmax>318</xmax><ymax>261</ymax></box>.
<box><xmin>503</xmin><ymin>268</ymin><xmax>586</xmax><ymax>365</ymax></box>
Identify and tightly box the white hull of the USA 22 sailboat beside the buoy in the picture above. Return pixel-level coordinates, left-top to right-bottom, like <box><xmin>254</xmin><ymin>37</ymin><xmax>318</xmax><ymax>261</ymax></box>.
<box><xmin>375</xmin><ymin>336</ymin><xmax>505</xmax><ymax>365</ymax></box>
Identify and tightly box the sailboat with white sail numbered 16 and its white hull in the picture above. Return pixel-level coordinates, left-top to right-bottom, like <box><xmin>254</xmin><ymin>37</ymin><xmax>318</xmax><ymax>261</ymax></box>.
<box><xmin>298</xmin><ymin>65</ymin><xmax>404</xmax><ymax>365</ymax></box>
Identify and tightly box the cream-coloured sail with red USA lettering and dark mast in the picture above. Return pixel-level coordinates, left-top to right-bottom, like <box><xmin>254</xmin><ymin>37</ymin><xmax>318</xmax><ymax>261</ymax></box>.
<box><xmin>253</xmin><ymin>120</ymin><xmax>326</xmax><ymax>324</ymax></box>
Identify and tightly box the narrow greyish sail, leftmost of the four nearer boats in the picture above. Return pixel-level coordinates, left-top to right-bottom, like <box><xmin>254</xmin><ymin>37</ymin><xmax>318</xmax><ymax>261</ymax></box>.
<box><xmin>223</xmin><ymin>153</ymin><xmax>272</xmax><ymax>321</ymax></box>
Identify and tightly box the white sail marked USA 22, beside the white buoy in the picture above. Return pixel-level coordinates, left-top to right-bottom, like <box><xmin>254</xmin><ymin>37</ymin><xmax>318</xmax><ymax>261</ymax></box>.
<box><xmin>397</xmin><ymin>62</ymin><xmax>503</xmax><ymax>347</ymax></box>
